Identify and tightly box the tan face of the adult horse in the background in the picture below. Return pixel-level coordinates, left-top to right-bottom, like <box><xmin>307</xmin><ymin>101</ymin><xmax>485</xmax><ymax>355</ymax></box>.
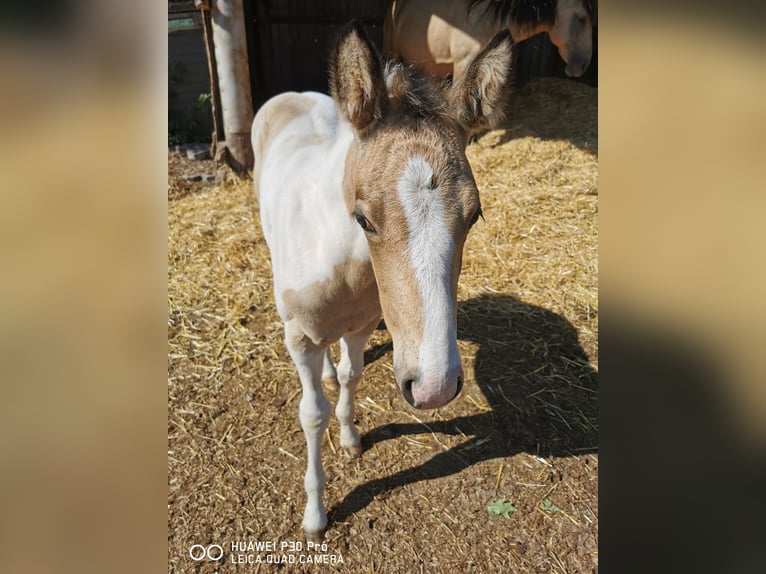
<box><xmin>550</xmin><ymin>0</ymin><xmax>593</xmax><ymax>77</ymax></box>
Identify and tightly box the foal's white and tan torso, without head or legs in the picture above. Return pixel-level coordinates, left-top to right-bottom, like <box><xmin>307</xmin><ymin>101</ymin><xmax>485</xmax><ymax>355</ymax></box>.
<box><xmin>253</xmin><ymin>92</ymin><xmax>381</xmax><ymax>345</ymax></box>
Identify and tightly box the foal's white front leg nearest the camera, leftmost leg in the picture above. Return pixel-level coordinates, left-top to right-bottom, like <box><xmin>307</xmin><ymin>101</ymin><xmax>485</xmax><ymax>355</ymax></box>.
<box><xmin>285</xmin><ymin>321</ymin><xmax>330</xmax><ymax>541</ymax></box>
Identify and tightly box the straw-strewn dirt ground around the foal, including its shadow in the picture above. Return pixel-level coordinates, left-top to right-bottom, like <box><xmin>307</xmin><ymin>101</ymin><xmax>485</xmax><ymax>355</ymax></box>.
<box><xmin>168</xmin><ymin>80</ymin><xmax>598</xmax><ymax>573</ymax></box>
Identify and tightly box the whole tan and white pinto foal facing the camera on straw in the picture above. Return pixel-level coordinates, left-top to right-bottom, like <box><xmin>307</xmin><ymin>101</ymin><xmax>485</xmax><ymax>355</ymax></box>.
<box><xmin>252</xmin><ymin>23</ymin><xmax>512</xmax><ymax>540</ymax></box>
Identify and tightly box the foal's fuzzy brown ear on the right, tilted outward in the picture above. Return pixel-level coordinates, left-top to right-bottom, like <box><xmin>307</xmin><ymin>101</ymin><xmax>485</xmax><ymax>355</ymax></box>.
<box><xmin>449</xmin><ymin>29</ymin><xmax>513</xmax><ymax>133</ymax></box>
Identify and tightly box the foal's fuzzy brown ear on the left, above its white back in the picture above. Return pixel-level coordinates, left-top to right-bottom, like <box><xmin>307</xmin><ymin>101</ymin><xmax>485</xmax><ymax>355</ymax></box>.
<box><xmin>330</xmin><ymin>20</ymin><xmax>388</xmax><ymax>135</ymax></box>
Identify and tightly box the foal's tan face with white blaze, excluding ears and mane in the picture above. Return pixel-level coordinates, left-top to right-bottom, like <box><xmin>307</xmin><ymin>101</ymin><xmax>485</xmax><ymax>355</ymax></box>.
<box><xmin>347</xmin><ymin>119</ymin><xmax>481</xmax><ymax>409</ymax></box>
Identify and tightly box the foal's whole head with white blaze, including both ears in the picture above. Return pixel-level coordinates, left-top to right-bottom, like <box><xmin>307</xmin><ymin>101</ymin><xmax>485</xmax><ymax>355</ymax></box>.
<box><xmin>330</xmin><ymin>24</ymin><xmax>511</xmax><ymax>409</ymax></box>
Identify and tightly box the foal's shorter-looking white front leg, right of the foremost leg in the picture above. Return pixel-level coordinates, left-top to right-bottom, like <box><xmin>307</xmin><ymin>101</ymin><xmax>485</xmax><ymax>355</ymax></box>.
<box><xmin>335</xmin><ymin>319</ymin><xmax>380</xmax><ymax>457</ymax></box>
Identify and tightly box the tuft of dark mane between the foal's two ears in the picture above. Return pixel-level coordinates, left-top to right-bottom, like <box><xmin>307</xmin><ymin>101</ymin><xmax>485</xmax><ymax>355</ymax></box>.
<box><xmin>385</xmin><ymin>62</ymin><xmax>447</xmax><ymax>119</ymax></box>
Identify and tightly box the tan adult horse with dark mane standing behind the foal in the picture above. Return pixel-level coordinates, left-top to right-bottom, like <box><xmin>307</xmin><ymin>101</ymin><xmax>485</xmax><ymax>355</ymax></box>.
<box><xmin>383</xmin><ymin>0</ymin><xmax>593</xmax><ymax>80</ymax></box>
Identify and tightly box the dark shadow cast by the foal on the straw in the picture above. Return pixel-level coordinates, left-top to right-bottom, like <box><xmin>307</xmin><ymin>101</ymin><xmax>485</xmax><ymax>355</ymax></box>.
<box><xmin>328</xmin><ymin>295</ymin><xmax>598</xmax><ymax>523</ymax></box>
